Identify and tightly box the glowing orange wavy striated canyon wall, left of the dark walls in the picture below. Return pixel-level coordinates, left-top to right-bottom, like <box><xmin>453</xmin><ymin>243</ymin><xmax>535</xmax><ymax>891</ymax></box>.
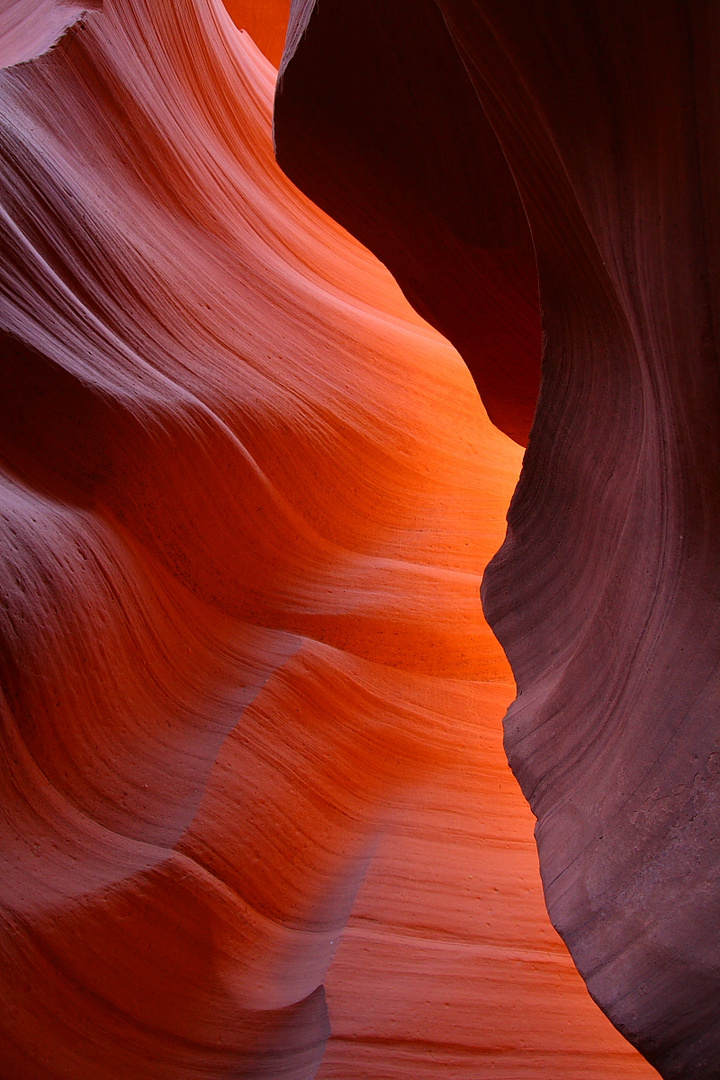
<box><xmin>0</xmin><ymin>0</ymin><xmax>651</xmax><ymax>1080</ymax></box>
